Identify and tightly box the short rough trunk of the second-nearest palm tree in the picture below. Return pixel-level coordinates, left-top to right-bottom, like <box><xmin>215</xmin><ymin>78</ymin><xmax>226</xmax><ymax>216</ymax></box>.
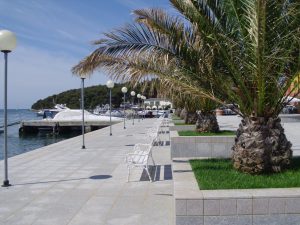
<box><xmin>196</xmin><ymin>112</ymin><xmax>220</xmax><ymax>132</ymax></box>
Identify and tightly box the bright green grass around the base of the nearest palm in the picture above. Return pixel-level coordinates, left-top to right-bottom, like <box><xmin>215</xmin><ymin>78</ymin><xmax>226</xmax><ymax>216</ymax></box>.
<box><xmin>190</xmin><ymin>157</ymin><xmax>300</xmax><ymax>190</ymax></box>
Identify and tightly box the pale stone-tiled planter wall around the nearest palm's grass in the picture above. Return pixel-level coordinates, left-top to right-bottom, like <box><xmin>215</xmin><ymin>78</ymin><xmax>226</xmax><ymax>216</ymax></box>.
<box><xmin>172</xmin><ymin>159</ymin><xmax>300</xmax><ymax>225</ymax></box>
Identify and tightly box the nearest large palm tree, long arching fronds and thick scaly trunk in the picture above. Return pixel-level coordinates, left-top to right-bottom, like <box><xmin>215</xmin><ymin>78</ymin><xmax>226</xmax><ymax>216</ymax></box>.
<box><xmin>73</xmin><ymin>0</ymin><xmax>300</xmax><ymax>173</ymax></box>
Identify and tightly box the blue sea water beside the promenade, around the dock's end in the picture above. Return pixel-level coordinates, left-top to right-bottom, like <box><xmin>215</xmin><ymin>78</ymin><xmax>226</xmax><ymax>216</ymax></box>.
<box><xmin>0</xmin><ymin>109</ymin><xmax>80</xmax><ymax>160</ymax></box>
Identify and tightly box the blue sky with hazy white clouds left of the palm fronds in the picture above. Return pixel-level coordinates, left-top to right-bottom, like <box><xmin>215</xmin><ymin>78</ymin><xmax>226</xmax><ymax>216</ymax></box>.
<box><xmin>0</xmin><ymin>0</ymin><xmax>171</xmax><ymax>109</ymax></box>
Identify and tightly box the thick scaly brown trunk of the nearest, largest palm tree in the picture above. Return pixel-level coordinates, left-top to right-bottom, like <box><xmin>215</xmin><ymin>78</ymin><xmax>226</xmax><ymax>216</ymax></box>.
<box><xmin>232</xmin><ymin>117</ymin><xmax>292</xmax><ymax>174</ymax></box>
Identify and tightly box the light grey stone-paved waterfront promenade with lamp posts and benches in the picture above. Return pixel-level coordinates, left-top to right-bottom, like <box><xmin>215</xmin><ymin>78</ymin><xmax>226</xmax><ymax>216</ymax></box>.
<box><xmin>0</xmin><ymin>119</ymin><xmax>174</xmax><ymax>225</ymax></box>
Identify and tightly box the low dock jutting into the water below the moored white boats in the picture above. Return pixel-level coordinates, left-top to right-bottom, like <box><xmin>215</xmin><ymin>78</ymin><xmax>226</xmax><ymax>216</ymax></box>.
<box><xmin>19</xmin><ymin>120</ymin><xmax>121</xmax><ymax>134</ymax></box>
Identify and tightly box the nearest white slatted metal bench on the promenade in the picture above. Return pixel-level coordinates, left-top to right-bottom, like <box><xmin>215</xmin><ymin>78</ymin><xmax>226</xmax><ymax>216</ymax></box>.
<box><xmin>125</xmin><ymin>144</ymin><xmax>155</xmax><ymax>182</ymax></box>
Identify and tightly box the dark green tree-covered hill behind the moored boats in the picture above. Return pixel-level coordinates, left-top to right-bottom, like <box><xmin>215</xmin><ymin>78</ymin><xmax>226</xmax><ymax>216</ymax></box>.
<box><xmin>31</xmin><ymin>84</ymin><xmax>156</xmax><ymax>110</ymax></box>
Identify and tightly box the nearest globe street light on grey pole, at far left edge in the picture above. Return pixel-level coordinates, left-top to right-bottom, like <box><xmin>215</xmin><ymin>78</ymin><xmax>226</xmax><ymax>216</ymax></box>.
<box><xmin>0</xmin><ymin>30</ymin><xmax>17</xmax><ymax>187</ymax></box>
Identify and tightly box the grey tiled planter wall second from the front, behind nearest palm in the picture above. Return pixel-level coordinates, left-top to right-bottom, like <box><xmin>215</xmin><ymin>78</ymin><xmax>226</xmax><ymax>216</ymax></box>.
<box><xmin>170</xmin><ymin>129</ymin><xmax>235</xmax><ymax>159</ymax></box>
